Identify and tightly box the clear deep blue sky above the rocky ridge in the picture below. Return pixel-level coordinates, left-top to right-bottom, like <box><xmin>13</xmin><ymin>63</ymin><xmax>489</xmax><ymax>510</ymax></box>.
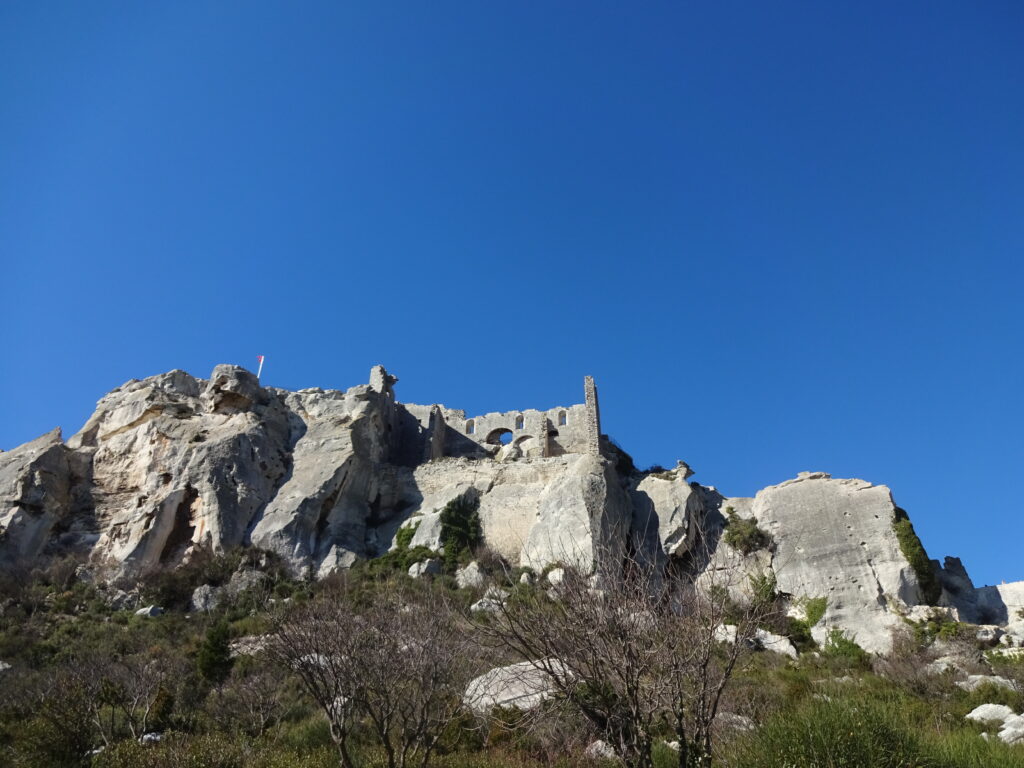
<box><xmin>0</xmin><ymin>0</ymin><xmax>1024</xmax><ymax>584</ymax></box>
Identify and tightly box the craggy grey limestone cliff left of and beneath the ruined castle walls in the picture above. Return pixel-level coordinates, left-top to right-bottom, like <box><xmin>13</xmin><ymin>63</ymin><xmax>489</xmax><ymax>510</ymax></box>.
<box><xmin>0</xmin><ymin>366</ymin><xmax>632</xmax><ymax>581</ymax></box>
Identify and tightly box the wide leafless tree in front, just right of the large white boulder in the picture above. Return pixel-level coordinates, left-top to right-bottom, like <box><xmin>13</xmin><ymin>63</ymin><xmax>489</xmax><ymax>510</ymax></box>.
<box><xmin>477</xmin><ymin>524</ymin><xmax>773</xmax><ymax>768</ymax></box>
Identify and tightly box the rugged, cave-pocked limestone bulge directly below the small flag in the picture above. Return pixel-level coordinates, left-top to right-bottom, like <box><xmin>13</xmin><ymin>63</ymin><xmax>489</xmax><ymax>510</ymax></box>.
<box><xmin>69</xmin><ymin>366</ymin><xmax>290</xmax><ymax>572</ymax></box>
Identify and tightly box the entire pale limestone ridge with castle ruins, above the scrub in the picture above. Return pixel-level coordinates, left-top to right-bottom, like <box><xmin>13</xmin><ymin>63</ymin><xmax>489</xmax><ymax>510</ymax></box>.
<box><xmin>0</xmin><ymin>366</ymin><xmax>1024</xmax><ymax>651</ymax></box>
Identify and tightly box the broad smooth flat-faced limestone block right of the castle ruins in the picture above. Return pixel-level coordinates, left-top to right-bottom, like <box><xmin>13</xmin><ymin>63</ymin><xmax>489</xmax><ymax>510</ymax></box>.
<box><xmin>724</xmin><ymin>472</ymin><xmax>923</xmax><ymax>652</ymax></box>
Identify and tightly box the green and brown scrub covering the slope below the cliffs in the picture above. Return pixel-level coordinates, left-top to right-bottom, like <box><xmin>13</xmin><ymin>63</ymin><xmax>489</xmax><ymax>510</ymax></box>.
<box><xmin>0</xmin><ymin>540</ymin><xmax>1024</xmax><ymax>768</ymax></box>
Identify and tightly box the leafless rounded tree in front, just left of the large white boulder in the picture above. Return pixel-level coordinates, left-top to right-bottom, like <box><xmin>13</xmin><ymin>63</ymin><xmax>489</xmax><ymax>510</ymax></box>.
<box><xmin>270</xmin><ymin>588</ymin><xmax>474</xmax><ymax>768</ymax></box>
